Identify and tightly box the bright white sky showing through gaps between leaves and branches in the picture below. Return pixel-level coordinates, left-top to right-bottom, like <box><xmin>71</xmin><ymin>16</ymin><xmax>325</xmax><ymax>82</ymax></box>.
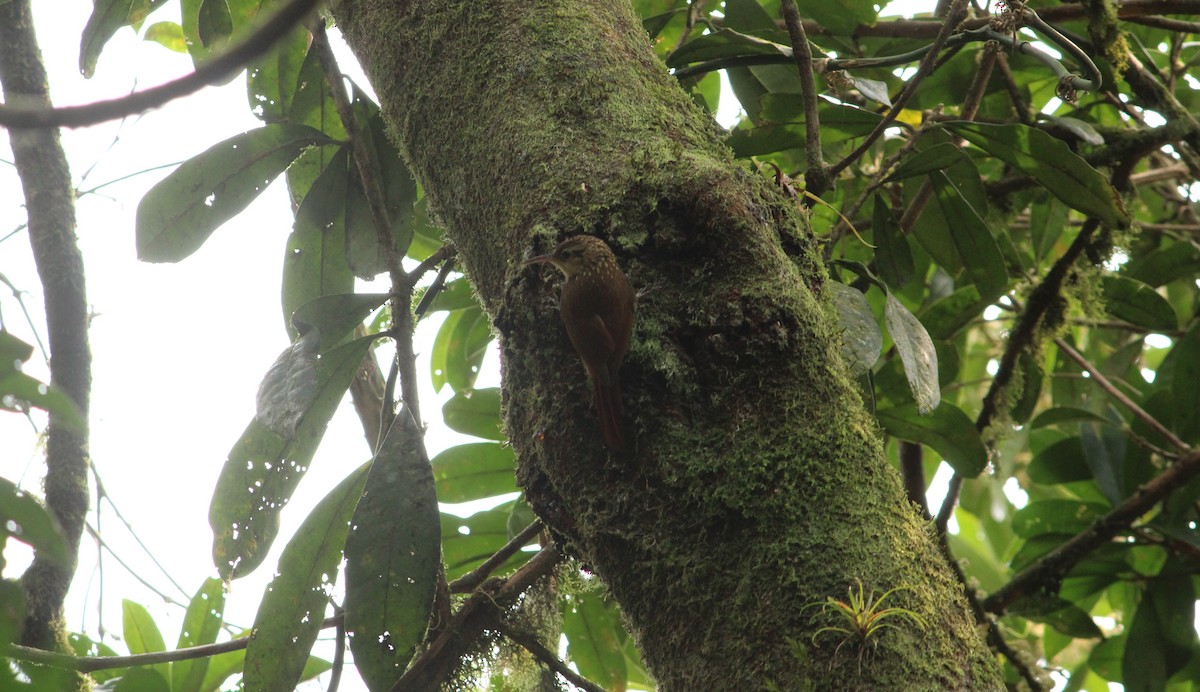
<box><xmin>0</xmin><ymin>0</ymin><xmax>931</xmax><ymax>691</ymax></box>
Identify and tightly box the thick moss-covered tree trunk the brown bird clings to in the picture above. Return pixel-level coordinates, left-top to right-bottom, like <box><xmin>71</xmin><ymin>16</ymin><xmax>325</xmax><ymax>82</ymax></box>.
<box><xmin>335</xmin><ymin>0</ymin><xmax>1001</xmax><ymax>690</ymax></box>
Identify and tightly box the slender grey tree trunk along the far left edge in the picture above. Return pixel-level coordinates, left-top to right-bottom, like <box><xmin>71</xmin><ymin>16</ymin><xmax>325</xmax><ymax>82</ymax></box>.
<box><xmin>0</xmin><ymin>0</ymin><xmax>91</xmax><ymax>650</ymax></box>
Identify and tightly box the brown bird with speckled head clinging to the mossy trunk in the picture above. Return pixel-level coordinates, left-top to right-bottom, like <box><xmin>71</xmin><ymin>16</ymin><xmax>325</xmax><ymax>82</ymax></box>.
<box><xmin>524</xmin><ymin>235</ymin><xmax>634</xmax><ymax>452</ymax></box>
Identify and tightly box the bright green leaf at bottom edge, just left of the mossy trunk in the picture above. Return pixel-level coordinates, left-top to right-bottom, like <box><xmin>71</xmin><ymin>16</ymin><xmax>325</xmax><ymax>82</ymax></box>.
<box><xmin>562</xmin><ymin>591</ymin><xmax>626</xmax><ymax>690</ymax></box>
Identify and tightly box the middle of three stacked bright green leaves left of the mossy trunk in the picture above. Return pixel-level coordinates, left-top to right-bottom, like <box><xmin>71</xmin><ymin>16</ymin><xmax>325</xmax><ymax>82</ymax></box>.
<box><xmin>433</xmin><ymin>443</ymin><xmax>517</xmax><ymax>503</ymax></box>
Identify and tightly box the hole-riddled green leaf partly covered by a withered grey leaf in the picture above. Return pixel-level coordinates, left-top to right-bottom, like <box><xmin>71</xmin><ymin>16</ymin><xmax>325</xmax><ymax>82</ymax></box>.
<box><xmin>209</xmin><ymin>337</ymin><xmax>372</xmax><ymax>579</ymax></box>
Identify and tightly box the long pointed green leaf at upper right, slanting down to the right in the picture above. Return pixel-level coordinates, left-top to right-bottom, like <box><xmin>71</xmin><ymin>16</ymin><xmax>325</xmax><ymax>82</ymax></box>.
<box><xmin>946</xmin><ymin>122</ymin><xmax>1129</xmax><ymax>228</ymax></box>
